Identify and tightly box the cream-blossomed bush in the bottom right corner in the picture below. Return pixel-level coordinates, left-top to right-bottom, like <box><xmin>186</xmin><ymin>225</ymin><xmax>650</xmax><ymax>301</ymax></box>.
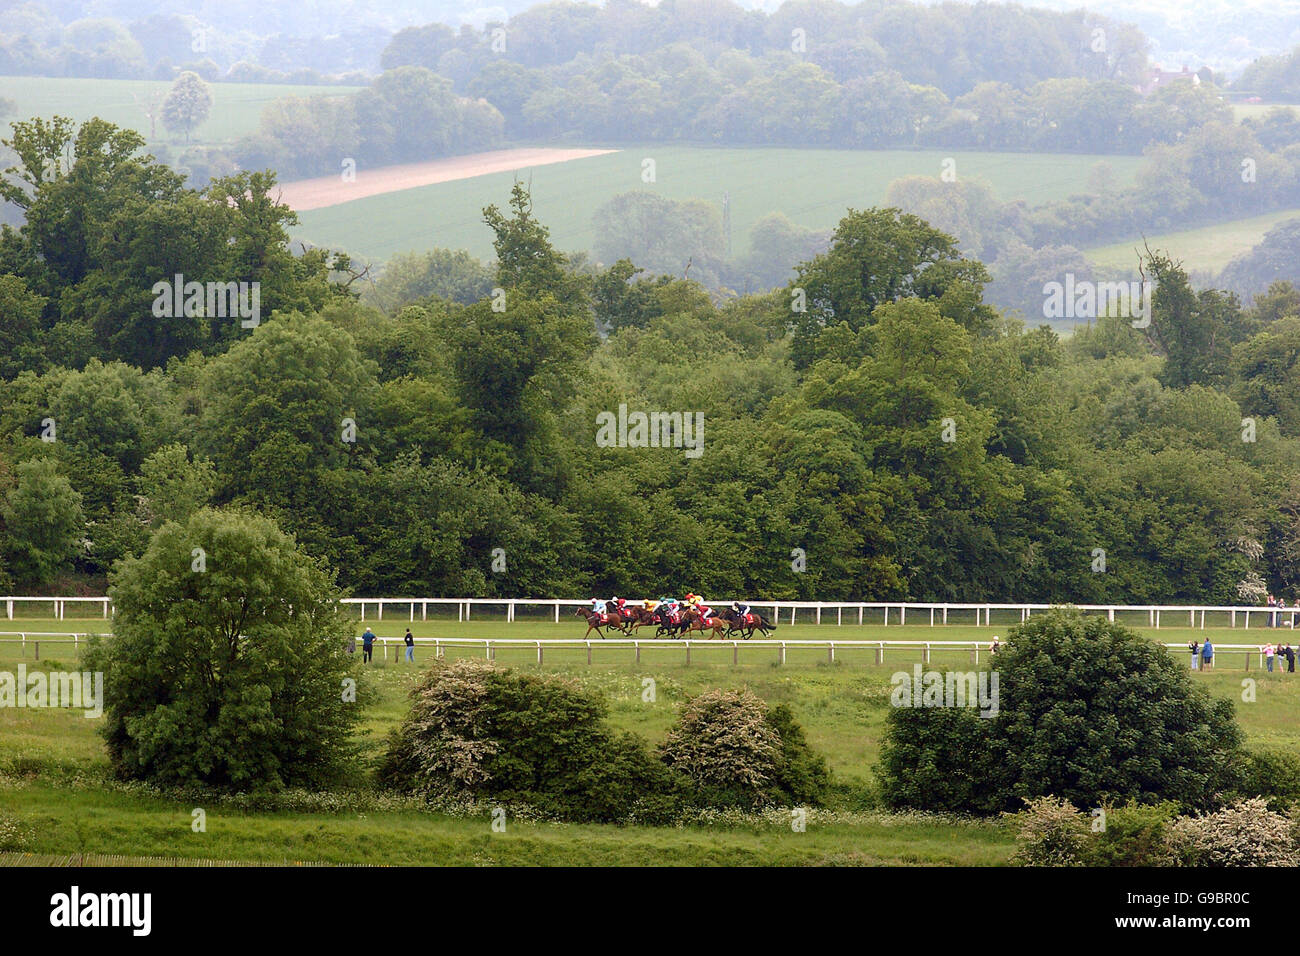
<box><xmin>1170</xmin><ymin>797</ymin><xmax>1300</xmax><ymax>866</ymax></box>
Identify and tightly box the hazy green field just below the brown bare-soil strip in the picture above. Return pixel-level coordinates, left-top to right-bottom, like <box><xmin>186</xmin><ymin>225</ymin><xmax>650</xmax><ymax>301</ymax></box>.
<box><xmin>295</xmin><ymin>143</ymin><xmax>1141</xmax><ymax>260</ymax></box>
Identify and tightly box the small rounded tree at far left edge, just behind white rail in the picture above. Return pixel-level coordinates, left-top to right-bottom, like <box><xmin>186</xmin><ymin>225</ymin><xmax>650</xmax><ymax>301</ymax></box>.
<box><xmin>0</xmin><ymin>458</ymin><xmax>86</xmax><ymax>587</ymax></box>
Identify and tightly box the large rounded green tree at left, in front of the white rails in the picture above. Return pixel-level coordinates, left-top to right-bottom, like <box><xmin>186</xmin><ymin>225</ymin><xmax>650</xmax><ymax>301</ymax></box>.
<box><xmin>88</xmin><ymin>510</ymin><xmax>361</xmax><ymax>790</ymax></box>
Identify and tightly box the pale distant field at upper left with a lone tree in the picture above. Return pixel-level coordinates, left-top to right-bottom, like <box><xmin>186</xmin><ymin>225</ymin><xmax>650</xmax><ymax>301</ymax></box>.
<box><xmin>0</xmin><ymin>77</ymin><xmax>359</xmax><ymax>148</ymax></box>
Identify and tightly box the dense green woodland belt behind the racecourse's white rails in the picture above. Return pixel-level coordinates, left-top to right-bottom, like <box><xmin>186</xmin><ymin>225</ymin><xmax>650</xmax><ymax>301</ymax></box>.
<box><xmin>0</xmin><ymin>120</ymin><xmax>1300</xmax><ymax>602</ymax></box>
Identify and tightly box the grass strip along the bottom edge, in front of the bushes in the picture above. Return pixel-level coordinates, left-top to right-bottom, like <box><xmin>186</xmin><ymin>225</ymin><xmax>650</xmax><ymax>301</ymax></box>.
<box><xmin>0</xmin><ymin>782</ymin><xmax>1014</xmax><ymax>866</ymax></box>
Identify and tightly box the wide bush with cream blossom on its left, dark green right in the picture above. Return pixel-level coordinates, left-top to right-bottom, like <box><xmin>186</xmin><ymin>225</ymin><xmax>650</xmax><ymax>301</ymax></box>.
<box><xmin>378</xmin><ymin>659</ymin><xmax>679</xmax><ymax>823</ymax></box>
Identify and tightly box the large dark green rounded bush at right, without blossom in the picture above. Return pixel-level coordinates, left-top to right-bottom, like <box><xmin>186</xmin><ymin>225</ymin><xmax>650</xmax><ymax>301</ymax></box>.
<box><xmin>880</xmin><ymin>610</ymin><xmax>1243</xmax><ymax>813</ymax></box>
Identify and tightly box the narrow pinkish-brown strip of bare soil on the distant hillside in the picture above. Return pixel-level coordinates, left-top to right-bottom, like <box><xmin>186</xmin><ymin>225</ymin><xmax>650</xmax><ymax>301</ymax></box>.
<box><xmin>280</xmin><ymin>147</ymin><xmax>615</xmax><ymax>212</ymax></box>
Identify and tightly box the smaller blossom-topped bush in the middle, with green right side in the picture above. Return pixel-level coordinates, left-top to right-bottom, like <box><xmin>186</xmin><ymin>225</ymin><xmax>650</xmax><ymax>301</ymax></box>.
<box><xmin>659</xmin><ymin>689</ymin><xmax>829</xmax><ymax>809</ymax></box>
